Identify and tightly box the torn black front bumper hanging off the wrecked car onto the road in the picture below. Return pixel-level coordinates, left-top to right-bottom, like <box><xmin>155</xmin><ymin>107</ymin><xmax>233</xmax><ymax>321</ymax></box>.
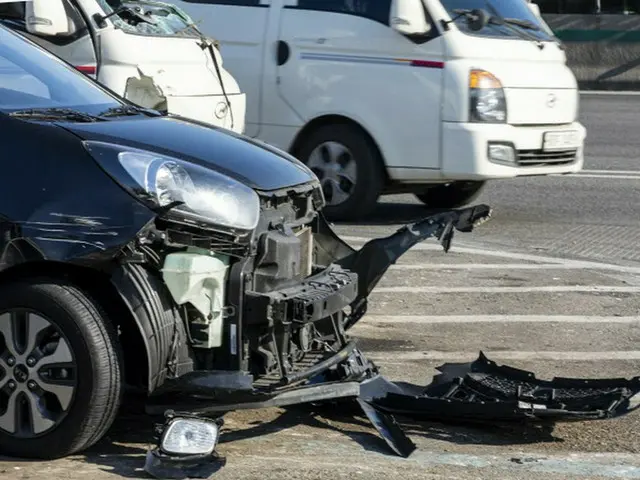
<box><xmin>142</xmin><ymin>206</ymin><xmax>640</xmax><ymax>480</ymax></box>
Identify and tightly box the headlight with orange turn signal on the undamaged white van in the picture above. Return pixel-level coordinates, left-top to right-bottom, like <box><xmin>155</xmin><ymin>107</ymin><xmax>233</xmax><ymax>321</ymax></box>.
<box><xmin>469</xmin><ymin>70</ymin><xmax>507</xmax><ymax>123</ymax></box>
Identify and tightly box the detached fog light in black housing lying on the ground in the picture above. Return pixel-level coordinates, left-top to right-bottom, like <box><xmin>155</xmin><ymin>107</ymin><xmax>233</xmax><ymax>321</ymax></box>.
<box><xmin>144</xmin><ymin>411</ymin><xmax>225</xmax><ymax>479</ymax></box>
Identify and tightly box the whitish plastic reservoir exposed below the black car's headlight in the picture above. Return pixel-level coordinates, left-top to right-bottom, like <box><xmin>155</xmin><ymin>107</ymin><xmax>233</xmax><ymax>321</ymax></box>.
<box><xmin>162</xmin><ymin>251</ymin><xmax>229</xmax><ymax>348</ymax></box>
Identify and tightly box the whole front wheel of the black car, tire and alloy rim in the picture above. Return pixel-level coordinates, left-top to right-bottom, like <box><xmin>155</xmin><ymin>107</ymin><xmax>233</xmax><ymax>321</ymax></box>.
<box><xmin>0</xmin><ymin>279</ymin><xmax>122</xmax><ymax>459</ymax></box>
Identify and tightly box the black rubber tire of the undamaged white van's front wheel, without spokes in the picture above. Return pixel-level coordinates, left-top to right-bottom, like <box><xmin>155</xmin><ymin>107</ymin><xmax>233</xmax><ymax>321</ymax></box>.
<box><xmin>297</xmin><ymin>124</ymin><xmax>385</xmax><ymax>220</ymax></box>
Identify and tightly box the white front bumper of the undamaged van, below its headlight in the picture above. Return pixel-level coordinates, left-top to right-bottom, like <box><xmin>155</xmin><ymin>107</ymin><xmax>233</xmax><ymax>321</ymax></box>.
<box><xmin>441</xmin><ymin>122</ymin><xmax>586</xmax><ymax>180</ymax></box>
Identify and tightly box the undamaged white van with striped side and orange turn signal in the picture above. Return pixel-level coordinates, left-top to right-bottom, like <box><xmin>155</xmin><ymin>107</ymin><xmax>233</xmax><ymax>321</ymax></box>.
<box><xmin>159</xmin><ymin>0</ymin><xmax>586</xmax><ymax>218</ymax></box>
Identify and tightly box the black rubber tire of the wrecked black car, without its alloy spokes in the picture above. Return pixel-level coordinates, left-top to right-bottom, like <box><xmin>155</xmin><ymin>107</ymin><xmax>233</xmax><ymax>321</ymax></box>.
<box><xmin>0</xmin><ymin>279</ymin><xmax>123</xmax><ymax>460</ymax></box>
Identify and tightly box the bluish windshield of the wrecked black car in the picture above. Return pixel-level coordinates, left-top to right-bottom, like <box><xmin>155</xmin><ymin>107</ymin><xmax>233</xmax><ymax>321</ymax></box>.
<box><xmin>0</xmin><ymin>26</ymin><xmax>123</xmax><ymax>114</ymax></box>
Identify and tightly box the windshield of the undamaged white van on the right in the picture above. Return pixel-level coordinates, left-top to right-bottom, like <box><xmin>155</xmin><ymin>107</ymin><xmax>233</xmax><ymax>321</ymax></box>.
<box><xmin>440</xmin><ymin>0</ymin><xmax>555</xmax><ymax>41</ymax></box>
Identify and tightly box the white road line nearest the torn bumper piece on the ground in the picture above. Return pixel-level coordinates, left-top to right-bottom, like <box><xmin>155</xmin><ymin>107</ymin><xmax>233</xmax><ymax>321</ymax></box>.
<box><xmin>367</xmin><ymin>350</ymin><xmax>640</xmax><ymax>364</ymax></box>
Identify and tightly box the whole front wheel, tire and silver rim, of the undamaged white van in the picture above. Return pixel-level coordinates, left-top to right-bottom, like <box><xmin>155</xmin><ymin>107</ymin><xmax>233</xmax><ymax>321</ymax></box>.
<box><xmin>298</xmin><ymin>124</ymin><xmax>384</xmax><ymax>220</ymax></box>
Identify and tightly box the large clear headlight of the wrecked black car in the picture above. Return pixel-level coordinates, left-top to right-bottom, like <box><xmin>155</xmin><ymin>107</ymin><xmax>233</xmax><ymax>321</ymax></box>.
<box><xmin>84</xmin><ymin>141</ymin><xmax>260</xmax><ymax>230</ymax></box>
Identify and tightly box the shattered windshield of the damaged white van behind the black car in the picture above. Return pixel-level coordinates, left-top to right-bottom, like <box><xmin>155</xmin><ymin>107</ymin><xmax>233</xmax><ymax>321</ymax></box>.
<box><xmin>97</xmin><ymin>0</ymin><xmax>202</xmax><ymax>38</ymax></box>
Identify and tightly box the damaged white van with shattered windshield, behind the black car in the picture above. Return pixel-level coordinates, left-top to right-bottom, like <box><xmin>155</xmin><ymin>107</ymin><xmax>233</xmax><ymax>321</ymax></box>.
<box><xmin>0</xmin><ymin>0</ymin><xmax>246</xmax><ymax>133</ymax></box>
